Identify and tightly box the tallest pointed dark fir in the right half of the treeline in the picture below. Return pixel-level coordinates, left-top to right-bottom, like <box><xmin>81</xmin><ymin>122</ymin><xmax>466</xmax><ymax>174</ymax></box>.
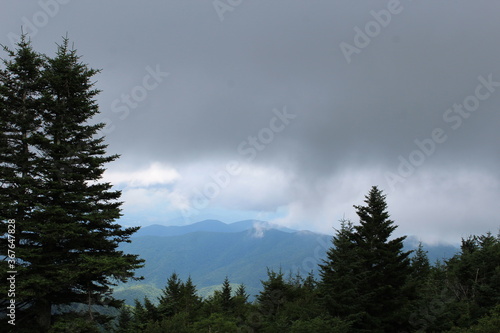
<box><xmin>354</xmin><ymin>186</ymin><xmax>411</xmax><ymax>332</ymax></box>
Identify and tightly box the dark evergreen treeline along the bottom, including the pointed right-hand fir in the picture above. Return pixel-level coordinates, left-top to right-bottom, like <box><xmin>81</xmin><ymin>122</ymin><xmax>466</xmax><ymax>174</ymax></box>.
<box><xmin>114</xmin><ymin>187</ymin><xmax>500</xmax><ymax>333</ymax></box>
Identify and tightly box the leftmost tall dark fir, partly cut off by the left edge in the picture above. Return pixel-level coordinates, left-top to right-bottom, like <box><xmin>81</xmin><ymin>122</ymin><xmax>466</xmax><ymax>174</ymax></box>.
<box><xmin>0</xmin><ymin>37</ymin><xmax>46</xmax><ymax>328</ymax></box>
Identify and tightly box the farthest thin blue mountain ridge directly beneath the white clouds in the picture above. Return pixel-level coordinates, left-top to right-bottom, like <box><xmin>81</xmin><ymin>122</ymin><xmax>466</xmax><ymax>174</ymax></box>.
<box><xmin>132</xmin><ymin>220</ymin><xmax>297</xmax><ymax>237</ymax></box>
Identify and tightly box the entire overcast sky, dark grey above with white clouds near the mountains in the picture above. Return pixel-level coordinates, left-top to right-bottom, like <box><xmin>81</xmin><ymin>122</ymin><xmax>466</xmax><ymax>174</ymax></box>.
<box><xmin>0</xmin><ymin>0</ymin><xmax>500</xmax><ymax>243</ymax></box>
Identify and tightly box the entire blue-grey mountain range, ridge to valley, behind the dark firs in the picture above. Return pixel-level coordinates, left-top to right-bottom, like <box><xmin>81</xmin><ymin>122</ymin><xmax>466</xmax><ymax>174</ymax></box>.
<box><xmin>115</xmin><ymin>220</ymin><xmax>458</xmax><ymax>304</ymax></box>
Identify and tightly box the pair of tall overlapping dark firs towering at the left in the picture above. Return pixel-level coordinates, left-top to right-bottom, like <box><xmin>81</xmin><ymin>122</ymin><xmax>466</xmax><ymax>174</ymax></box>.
<box><xmin>0</xmin><ymin>39</ymin><xmax>142</xmax><ymax>331</ymax></box>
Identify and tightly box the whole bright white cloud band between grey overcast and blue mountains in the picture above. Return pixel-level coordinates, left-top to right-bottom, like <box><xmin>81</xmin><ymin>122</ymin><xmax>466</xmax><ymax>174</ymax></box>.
<box><xmin>106</xmin><ymin>161</ymin><xmax>500</xmax><ymax>243</ymax></box>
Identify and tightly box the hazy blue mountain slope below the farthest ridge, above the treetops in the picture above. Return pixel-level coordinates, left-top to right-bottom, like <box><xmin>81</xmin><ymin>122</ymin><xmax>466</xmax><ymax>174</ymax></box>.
<box><xmin>121</xmin><ymin>230</ymin><xmax>330</xmax><ymax>287</ymax></box>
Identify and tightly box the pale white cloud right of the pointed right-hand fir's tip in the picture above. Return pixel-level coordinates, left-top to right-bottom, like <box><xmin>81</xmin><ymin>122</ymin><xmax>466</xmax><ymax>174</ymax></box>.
<box><xmin>388</xmin><ymin>169</ymin><xmax>500</xmax><ymax>242</ymax></box>
